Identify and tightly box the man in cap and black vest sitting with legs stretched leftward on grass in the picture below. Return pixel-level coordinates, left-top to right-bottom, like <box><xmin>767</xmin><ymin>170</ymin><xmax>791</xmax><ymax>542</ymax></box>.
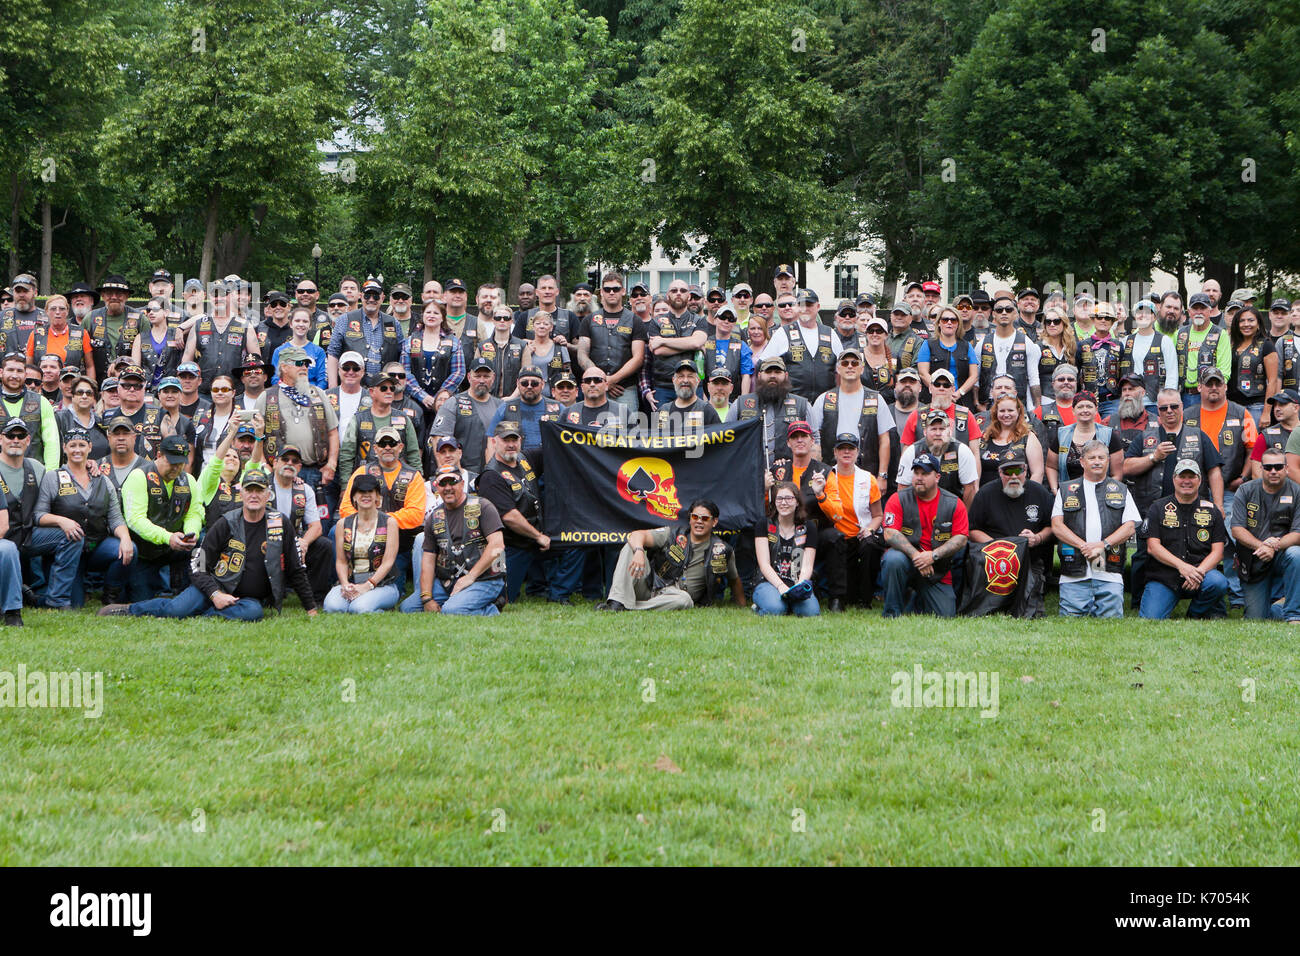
<box><xmin>99</xmin><ymin>464</ymin><xmax>316</xmax><ymax>620</ymax></box>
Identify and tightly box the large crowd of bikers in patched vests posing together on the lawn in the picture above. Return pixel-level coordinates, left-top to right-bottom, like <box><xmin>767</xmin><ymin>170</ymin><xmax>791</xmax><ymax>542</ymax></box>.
<box><xmin>0</xmin><ymin>265</ymin><xmax>1300</xmax><ymax>624</ymax></box>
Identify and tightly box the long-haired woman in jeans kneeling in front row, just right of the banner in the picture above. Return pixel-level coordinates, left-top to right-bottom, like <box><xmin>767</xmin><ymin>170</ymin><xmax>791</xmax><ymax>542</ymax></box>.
<box><xmin>754</xmin><ymin>481</ymin><xmax>822</xmax><ymax>618</ymax></box>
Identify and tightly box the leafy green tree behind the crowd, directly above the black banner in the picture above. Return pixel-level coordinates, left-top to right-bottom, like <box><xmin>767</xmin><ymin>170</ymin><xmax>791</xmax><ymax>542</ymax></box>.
<box><xmin>645</xmin><ymin>0</ymin><xmax>839</xmax><ymax>282</ymax></box>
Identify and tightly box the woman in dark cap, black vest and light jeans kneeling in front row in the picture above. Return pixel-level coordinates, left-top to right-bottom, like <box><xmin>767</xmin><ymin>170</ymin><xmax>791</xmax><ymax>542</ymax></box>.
<box><xmin>325</xmin><ymin>476</ymin><xmax>400</xmax><ymax>614</ymax></box>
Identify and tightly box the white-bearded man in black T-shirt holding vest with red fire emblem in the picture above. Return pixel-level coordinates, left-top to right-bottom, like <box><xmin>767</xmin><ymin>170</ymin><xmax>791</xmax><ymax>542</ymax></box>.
<box><xmin>970</xmin><ymin>455</ymin><xmax>1052</xmax><ymax>618</ymax></box>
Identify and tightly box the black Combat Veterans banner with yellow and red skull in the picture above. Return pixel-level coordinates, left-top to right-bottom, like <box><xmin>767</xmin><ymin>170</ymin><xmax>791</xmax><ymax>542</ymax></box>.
<box><xmin>542</xmin><ymin>419</ymin><xmax>763</xmax><ymax>545</ymax></box>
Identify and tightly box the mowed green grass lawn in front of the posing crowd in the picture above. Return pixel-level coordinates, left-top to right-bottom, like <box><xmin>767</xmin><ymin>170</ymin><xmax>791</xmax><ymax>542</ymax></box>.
<box><xmin>0</xmin><ymin>601</ymin><xmax>1300</xmax><ymax>865</ymax></box>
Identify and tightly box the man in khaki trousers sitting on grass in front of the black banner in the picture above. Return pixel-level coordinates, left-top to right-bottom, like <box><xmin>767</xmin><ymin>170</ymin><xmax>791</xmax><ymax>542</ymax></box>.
<box><xmin>597</xmin><ymin>498</ymin><xmax>746</xmax><ymax>611</ymax></box>
